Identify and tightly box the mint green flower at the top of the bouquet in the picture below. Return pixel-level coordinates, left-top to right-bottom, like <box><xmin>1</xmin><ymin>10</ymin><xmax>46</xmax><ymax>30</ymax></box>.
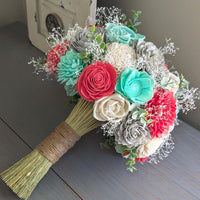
<box><xmin>106</xmin><ymin>23</ymin><xmax>145</xmax><ymax>44</ymax></box>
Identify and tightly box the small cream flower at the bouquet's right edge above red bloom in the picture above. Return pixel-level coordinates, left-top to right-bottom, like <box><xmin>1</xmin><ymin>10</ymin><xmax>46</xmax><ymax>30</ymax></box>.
<box><xmin>161</xmin><ymin>72</ymin><xmax>180</xmax><ymax>94</ymax></box>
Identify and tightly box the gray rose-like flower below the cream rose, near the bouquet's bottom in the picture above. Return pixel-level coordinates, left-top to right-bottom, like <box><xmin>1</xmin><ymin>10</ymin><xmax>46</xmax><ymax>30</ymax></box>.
<box><xmin>114</xmin><ymin>113</ymin><xmax>151</xmax><ymax>147</ymax></box>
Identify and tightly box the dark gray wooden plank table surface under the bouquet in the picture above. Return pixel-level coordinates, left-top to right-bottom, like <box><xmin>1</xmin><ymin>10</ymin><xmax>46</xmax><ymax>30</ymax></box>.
<box><xmin>0</xmin><ymin>23</ymin><xmax>200</xmax><ymax>200</ymax></box>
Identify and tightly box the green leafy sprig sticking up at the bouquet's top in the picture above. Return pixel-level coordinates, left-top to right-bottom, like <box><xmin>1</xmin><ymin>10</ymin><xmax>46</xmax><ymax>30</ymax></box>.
<box><xmin>121</xmin><ymin>10</ymin><xmax>142</xmax><ymax>32</ymax></box>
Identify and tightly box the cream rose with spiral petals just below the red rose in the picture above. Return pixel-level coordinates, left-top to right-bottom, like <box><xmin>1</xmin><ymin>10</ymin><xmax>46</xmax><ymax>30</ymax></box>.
<box><xmin>93</xmin><ymin>93</ymin><xmax>130</xmax><ymax>122</ymax></box>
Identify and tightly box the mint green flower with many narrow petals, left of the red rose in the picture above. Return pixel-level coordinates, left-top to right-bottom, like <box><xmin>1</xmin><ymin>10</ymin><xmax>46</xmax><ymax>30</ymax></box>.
<box><xmin>57</xmin><ymin>50</ymin><xmax>86</xmax><ymax>96</ymax></box>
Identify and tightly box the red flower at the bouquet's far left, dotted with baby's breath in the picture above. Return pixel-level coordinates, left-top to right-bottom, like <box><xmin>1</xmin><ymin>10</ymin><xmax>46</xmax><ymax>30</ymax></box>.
<box><xmin>46</xmin><ymin>41</ymin><xmax>69</xmax><ymax>74</ymax></box>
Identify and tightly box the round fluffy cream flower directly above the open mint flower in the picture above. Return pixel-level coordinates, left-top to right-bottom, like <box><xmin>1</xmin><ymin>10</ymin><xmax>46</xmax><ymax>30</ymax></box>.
<box><xmin>104</xmin><ymin>42</ymin><xmax>136</xmax><ymax>74</ymax></box>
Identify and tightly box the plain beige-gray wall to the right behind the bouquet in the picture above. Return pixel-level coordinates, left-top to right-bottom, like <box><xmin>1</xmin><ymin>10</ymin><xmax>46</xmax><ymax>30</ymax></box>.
<box><xmin>98</xmin><ymin>0</ymin><xmax>200</xmax><ymax>129</ymax></box>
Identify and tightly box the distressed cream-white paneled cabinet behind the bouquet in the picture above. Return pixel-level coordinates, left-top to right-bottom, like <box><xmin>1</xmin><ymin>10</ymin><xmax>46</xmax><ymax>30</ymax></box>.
<box><xmin>26</xmin><ymin>0</ymin><xmax>97</xmax><ymax>52</ymax></box>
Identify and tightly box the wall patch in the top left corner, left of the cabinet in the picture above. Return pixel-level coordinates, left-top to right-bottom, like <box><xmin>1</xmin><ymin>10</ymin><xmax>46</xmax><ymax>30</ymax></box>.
<box><xmin>0</xmin><ymin>0</ymin><xmax>26</xmax><ymax>27</ymax></box>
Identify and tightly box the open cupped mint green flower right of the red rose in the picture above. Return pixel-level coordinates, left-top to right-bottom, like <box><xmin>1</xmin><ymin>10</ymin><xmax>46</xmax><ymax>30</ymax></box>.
<box><xmin>115</xmin><ymin>68</ymin><xmax>154</xmax><ymax>104</ymax></box>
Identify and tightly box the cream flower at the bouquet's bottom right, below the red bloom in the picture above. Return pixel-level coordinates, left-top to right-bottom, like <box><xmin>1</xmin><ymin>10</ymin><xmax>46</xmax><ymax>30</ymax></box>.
<box><xmin>136</xmin><ymin>134</ymin><xmax>169</xmax><ymax>158</ymax></box>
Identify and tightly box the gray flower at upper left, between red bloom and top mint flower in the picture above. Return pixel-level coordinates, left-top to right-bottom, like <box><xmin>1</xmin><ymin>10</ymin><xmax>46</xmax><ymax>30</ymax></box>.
<box><xmin>70</xmin><ymin>28</ymin><xmax>107</xmax><ymax>53</ymax></box>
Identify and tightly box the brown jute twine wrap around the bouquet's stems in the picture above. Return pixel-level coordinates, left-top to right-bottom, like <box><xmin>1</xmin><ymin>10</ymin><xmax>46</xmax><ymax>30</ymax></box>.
<box><xmin>36</xmin><ymin>122</ymin><xmax>80</xmax><ymax>164</ymax></box>
